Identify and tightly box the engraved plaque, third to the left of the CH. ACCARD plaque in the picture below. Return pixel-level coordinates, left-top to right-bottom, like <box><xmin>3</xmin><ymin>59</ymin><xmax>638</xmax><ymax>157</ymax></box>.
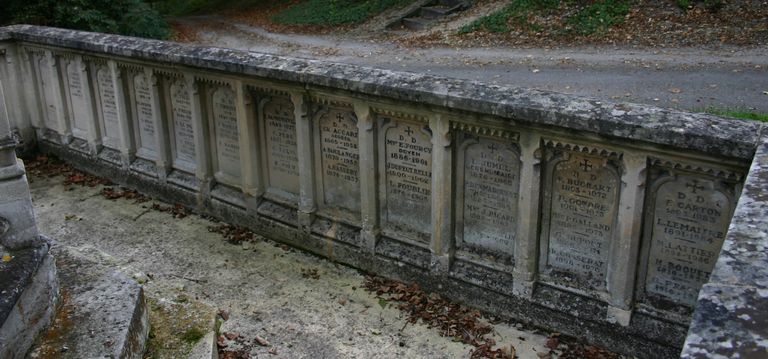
<box><xmin>171</xmin><ymin>80</ymin><xmax>196</xmax><ymax>167</ymax></box>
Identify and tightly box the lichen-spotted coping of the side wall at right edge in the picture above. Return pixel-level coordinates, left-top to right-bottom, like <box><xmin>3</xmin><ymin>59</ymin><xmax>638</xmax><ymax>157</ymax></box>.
<box><xmin>682</xmin><ymin>131</ymin><xmax>768</xmax><ymax>358</ymax></box>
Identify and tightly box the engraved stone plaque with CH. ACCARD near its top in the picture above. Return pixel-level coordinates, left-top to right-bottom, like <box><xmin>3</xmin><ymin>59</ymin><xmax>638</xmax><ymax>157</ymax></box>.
<box><xmin>320</xmin><ymin>108</ymin><xmax>360</xmax><ymax>212</ymax></box>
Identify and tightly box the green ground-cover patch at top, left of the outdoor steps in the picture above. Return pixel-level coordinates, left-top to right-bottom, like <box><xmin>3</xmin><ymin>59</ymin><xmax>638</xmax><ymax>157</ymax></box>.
<box><xmin>272</xmin><ymin>0</ymin><xmax>412</xmax><ymax>25</ymax></box>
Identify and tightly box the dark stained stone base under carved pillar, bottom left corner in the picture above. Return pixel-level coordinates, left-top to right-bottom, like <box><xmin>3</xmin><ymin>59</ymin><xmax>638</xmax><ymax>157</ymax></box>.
<box><xmin>0</xmin><ymin>240</ymin><xmax>59</xmax><ymax>359</ymax></box>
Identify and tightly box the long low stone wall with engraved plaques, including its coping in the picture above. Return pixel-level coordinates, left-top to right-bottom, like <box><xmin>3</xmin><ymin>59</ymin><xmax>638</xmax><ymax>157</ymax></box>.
<box><xmin>0</xmin><ymin>26</ymin><xmax>761</xmax><ymax>358</ymax></box>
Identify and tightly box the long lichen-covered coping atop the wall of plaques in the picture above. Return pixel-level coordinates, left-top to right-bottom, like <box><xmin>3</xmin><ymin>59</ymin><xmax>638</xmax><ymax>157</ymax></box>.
<box><xmin>0</xmin><ymin>25</ymin><xmax>763</xmax><ymax>160</ymax></box>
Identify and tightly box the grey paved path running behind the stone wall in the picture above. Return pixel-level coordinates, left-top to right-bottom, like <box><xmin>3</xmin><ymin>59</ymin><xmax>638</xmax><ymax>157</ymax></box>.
<box><xmin>184</xmin><ymin>17</ymin><xmax>768</xmax><ymax>113</ymax></box>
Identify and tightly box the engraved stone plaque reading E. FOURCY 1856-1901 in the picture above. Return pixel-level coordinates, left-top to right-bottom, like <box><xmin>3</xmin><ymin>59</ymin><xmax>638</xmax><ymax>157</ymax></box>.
<box><xmin>384</xmin><ymin>120</ymin><xmax>432</xmax><ymax>239</ymax></box>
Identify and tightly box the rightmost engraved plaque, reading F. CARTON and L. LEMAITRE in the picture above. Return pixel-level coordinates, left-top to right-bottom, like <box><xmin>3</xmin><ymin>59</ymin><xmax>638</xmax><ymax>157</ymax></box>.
<box><xmin>645</xmin><ymin>175</ymin><xmax>733</xmax><ymax>306</ymax></box>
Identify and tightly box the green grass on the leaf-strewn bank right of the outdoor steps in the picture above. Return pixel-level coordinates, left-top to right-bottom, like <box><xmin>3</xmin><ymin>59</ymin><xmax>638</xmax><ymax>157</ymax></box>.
<box><xmin>459</xmin><ymin>0</ymin><xmax>630</xmax><ymax>35</ymax></box>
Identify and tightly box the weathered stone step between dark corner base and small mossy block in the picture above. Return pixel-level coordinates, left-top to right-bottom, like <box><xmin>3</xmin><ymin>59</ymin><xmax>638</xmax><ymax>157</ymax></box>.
<box><xmin>27</xmin><ymin>246</ymin><xmax>149</xmax><ymax>359</ymax></box>
